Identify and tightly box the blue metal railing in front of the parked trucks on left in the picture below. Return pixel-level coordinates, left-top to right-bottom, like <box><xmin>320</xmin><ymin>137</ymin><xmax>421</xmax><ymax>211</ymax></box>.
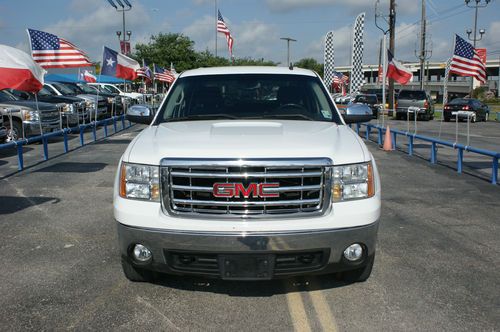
<box><xmin>0</xmin><ymin>115</ymin><xmax>132</xmax><ymax>171</ymax></box>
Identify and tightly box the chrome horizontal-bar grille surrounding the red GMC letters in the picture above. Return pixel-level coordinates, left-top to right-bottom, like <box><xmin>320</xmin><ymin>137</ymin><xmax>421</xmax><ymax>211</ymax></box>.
<box><xmin>161</xmin><ymin>158</ymin><xmax>332</xmax><ymax>218</ymax></box>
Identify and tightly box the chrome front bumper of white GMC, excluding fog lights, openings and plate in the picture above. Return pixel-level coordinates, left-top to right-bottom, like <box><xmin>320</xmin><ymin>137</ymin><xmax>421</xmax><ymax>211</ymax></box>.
<box><xmin>117</xmin><ymin>221</ymin><xmax>379</xmax><ymax>278</ymax></box>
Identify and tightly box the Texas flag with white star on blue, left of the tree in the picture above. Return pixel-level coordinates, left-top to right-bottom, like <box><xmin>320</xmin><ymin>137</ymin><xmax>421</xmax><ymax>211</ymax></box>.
<box><xmin>101</xmin><ymin>47</ymin><xmax>141</xmax><ymax>81</ymax></box>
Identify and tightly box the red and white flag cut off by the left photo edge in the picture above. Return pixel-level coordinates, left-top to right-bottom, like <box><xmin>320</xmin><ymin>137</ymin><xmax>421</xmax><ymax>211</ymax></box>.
<box><xmin>0</xmin><ymin>45</ymin><xmax>46</xmax><ymax>92</ymax></box>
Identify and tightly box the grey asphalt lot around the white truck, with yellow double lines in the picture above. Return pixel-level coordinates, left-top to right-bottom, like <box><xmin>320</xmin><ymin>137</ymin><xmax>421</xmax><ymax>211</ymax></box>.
<box><xmin>0</xmin><ymin>124</ymin><xmax>500</xmax><ymax>331</ymax></box>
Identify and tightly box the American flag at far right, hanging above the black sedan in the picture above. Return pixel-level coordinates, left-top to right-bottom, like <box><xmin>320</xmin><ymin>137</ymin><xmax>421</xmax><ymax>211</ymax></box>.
<box><xmin>450</xmin><ymin>35</ymin><xmax>486</xmax><ymax>83</ymax></box>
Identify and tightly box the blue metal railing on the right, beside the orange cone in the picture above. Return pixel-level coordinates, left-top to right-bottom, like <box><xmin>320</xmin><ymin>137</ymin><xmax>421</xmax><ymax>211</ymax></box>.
<box><xmin>356</xmin><ymin>123</ymin><xmax>500</xmax><ymax>184</ymax></box>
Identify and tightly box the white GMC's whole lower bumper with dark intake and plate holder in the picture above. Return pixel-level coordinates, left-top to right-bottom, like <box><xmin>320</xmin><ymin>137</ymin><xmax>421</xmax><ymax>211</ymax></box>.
<box><xmin>117</xmin><ymin>221</ymin><xmax>379</xmax><ymax>280</ymax></box>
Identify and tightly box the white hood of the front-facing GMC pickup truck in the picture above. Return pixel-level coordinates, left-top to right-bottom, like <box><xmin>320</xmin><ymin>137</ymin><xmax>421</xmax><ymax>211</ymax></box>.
<box><xmin>124</xmin><ymin>120</ymin><xmax>370</xmax><ymax>165</ymax></box>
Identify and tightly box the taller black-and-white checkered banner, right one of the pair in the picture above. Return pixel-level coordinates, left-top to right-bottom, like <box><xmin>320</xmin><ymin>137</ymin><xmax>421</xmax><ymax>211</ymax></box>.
<box><xmin>349</xmin><ymin>13</ymin><xmax>365</xmax><ymax>94</ymax></box>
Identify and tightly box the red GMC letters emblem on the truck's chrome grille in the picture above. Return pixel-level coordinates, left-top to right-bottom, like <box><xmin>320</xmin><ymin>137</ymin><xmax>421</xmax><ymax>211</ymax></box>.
<box><xmin>213</xmin><ymin>182</ymin><xmax>280</xmax><ymax>198</ymax></box>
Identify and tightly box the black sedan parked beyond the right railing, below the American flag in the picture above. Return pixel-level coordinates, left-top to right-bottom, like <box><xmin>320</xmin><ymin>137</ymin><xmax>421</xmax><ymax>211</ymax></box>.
<box><xmin>443</xmin><ymin>98</ymin><xmax>490</xmax><ymax>122</ymax></box>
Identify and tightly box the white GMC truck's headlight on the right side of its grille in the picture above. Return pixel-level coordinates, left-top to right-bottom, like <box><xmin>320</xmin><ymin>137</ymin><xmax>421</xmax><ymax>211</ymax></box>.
<box><xmin>332</xmin><ymin>162</ymin><xmax>375</xmax><ymax>202</ymax></box>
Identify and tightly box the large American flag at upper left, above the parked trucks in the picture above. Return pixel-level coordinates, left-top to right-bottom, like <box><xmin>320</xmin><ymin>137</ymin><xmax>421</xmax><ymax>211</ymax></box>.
<box><xmin>28</xmin><ymin>29</ymin><xmax>92</xmax><ymax>68</ymax></box>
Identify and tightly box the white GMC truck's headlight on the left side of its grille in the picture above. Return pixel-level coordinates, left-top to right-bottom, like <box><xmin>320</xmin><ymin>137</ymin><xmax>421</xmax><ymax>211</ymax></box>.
<box><xmin>120</xmin><ymin>163</ymin><xmax>160</xmax><ymax>202</ymax></box>
